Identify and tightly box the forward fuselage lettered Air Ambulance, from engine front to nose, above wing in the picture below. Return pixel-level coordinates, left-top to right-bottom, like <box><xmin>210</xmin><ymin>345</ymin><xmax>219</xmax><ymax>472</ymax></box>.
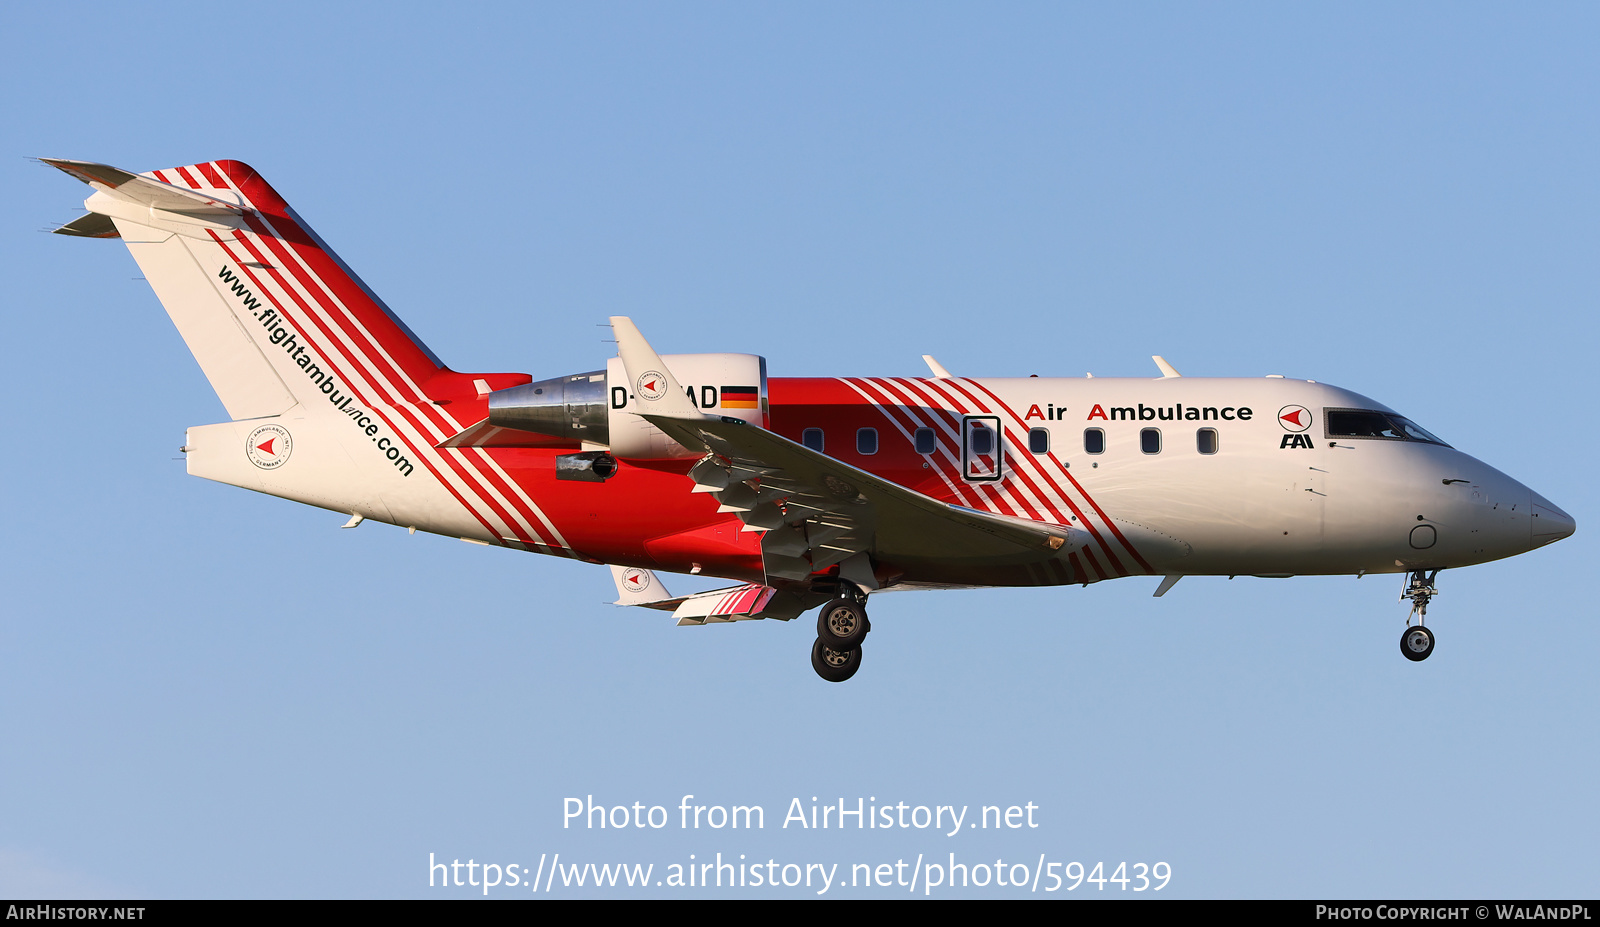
<box><xmin>770</xmin><ymin>376</ymin><xmax>1565</xmax><ymax>581</ymax></box>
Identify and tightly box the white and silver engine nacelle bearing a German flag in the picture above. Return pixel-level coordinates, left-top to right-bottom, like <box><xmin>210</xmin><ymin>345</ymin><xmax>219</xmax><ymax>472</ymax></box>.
<box><xmin>490</xmin><ymin>354</ymin><xmax>766</xmax><ymax>459</ymax></box>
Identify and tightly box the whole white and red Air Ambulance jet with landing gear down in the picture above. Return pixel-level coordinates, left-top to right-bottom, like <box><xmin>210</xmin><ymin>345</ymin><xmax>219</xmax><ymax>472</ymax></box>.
<box><xmin>46</xmin><ymin>160</ymin><xmax>1574</xmax><ymax>682</ymax></box>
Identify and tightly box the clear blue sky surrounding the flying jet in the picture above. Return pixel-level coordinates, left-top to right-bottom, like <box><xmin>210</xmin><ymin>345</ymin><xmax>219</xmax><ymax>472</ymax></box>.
<box><xmin>0</xmin><ymin>3</ymin><xmax>1600</xmax><ymax>898</ymax></box>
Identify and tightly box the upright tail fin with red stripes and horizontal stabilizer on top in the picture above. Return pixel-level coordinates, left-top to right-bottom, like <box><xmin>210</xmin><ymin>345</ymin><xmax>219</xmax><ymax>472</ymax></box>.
<box><xmin>45</xmin><ymin>160</ymin><xmax>467</xmax><ymax>419</ymax></box>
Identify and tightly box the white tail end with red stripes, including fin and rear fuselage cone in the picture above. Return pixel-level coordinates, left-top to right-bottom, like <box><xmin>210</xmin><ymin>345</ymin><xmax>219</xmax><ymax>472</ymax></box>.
<box><xmin>45</xmin><ymin>159</ymin><xmax>566</xmax><ymax>551</ymax></box>
